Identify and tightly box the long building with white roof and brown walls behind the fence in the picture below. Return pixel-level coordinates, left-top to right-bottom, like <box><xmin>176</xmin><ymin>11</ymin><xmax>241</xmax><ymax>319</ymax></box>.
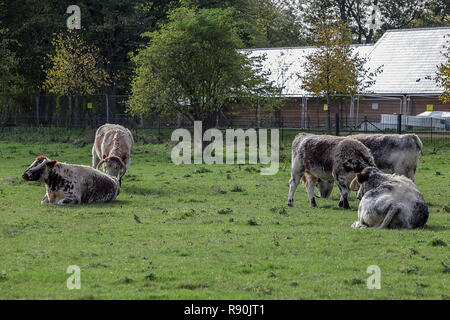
<box><xmin>227</xmin><ymin>27</ymin><xmax>450</xmax><ymax>128</ymax></box>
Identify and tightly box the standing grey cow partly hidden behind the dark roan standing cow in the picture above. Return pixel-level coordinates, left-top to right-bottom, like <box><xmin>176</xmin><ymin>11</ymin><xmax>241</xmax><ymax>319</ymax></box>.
<box><xmin>301</xmin><ymin>134</ymin><xmax>422</xmax><ymax>198</ymax></box>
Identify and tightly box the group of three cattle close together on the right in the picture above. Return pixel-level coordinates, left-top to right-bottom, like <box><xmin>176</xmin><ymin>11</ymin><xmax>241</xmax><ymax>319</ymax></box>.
<box><xmin>288</xmin><ymin>133</ymin><xmax>428</xmax><ymax>228</ymax></box>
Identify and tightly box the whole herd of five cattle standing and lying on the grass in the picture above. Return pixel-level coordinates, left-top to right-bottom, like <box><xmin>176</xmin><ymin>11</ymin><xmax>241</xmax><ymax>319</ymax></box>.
<box><xmin>22</xmin><ymin>124</ymin><xmax>428</xmax><ymax>228</ymax></box>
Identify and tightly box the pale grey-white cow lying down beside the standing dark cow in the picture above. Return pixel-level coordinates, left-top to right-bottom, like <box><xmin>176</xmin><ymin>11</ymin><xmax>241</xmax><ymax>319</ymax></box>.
<box><xmin>352</xmin><ymin>167</ymin><xmax>428</xmax><ymax>229</ymax></box>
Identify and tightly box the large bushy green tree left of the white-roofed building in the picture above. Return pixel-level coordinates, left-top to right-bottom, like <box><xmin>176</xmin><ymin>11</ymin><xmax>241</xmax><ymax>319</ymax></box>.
<box><xmin>128</xmin><ymin>7</ymin><xmax>275</xmax><ymax>130</ymax></box>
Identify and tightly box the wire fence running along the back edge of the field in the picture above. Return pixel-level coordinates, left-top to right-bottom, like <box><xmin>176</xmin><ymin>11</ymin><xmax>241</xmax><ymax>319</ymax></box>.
<box><xmin>0</xmin><ymin>94</ymin><xmax>450</xmax><ymax>147</ymax></box>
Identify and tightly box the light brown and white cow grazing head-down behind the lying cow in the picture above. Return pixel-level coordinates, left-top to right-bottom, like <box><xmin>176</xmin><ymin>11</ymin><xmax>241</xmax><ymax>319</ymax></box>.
<box><xmin>92</xmin><ymin>123</ymin><xmax>134</xmax><ymax>181</ymax></box>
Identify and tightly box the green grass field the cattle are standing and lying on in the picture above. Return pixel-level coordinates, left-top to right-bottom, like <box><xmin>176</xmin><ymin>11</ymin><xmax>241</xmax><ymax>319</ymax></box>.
<box><xmin>0</xmin><ymin>129</ymin><xmax>450</xmax><ymax>299</ymax></box>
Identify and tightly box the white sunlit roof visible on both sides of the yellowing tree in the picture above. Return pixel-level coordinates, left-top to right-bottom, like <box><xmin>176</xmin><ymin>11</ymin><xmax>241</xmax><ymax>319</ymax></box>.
<box><xmin>241</xmin><ymin>27</ymin><xmax>450</xmax><ymax>97</ymax></box>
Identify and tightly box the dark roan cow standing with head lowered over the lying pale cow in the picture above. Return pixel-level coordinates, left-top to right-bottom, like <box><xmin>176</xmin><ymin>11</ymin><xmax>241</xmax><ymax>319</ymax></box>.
<box><xmin>287</xmin><ymin>134</ymin><xmax>375</xmax><ymax>209</ymax></box>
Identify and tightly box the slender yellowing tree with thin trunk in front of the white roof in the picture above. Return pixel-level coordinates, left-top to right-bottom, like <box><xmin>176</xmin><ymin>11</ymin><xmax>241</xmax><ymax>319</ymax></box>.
<box><xmin>298</xmin><ymin>20</ymin><xmax>380</xmax><ymax>133</ymax></box>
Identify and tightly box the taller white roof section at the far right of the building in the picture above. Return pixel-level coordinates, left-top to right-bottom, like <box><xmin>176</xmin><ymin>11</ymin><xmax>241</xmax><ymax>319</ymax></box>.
<box><xmin>366</xmin><ymin>27</ymin><xmax>450</xmax><ymax>94</ymax></box>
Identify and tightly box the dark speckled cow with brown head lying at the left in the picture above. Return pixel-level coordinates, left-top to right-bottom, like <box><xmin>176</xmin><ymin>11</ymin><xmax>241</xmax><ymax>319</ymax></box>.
<box><xmin>22</xmin><ymin>156</ymin><xmax>120</xmax><ymax>204</ymax></box>
